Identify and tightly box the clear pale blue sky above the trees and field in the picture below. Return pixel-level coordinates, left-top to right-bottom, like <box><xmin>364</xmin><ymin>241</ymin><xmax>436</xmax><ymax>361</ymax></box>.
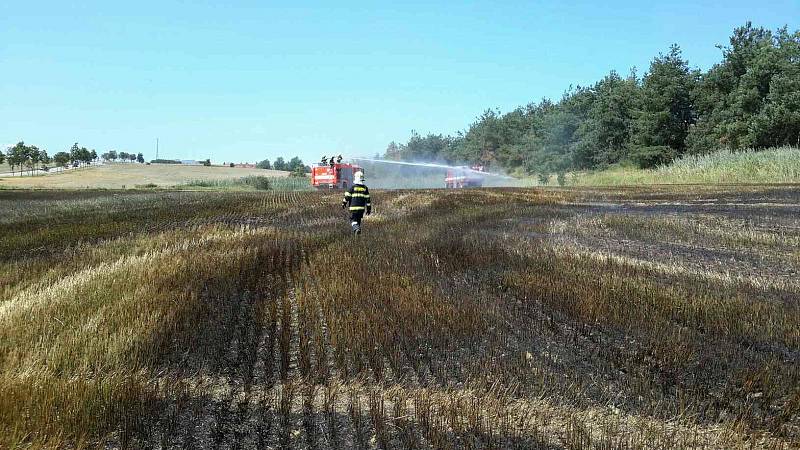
<box><xmin>0</xmin><ymin>0</ymin><xmax>800</xmax><ymax>162</ymax></box>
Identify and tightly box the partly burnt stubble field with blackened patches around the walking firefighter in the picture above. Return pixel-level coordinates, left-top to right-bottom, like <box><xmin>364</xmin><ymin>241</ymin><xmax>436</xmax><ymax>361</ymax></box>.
<box><xmin>0</xmin><ymin>186</ymin><xmax>800</xmax><ymax>449</ymax></box>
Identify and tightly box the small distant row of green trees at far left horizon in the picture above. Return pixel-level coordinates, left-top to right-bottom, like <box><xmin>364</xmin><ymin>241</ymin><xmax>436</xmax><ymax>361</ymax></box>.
<box><xmin>0</xmin><ymin>141</ymin><xmax>144</xmax><ymax>173</ymax></box>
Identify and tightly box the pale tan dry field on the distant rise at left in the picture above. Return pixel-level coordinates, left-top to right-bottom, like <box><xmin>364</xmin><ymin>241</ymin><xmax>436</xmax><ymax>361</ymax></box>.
<box><xmin>0</xmin><ymin>163</ymin><xmax>289</xmax><ymax>189</ymax></box>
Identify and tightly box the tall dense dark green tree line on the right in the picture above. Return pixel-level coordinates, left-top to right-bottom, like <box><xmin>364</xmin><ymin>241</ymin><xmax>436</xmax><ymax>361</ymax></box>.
<box><xmin>384</xmin><ymin>23</ymin><xmax>800</xmax><ymax>174</ymax></box>
